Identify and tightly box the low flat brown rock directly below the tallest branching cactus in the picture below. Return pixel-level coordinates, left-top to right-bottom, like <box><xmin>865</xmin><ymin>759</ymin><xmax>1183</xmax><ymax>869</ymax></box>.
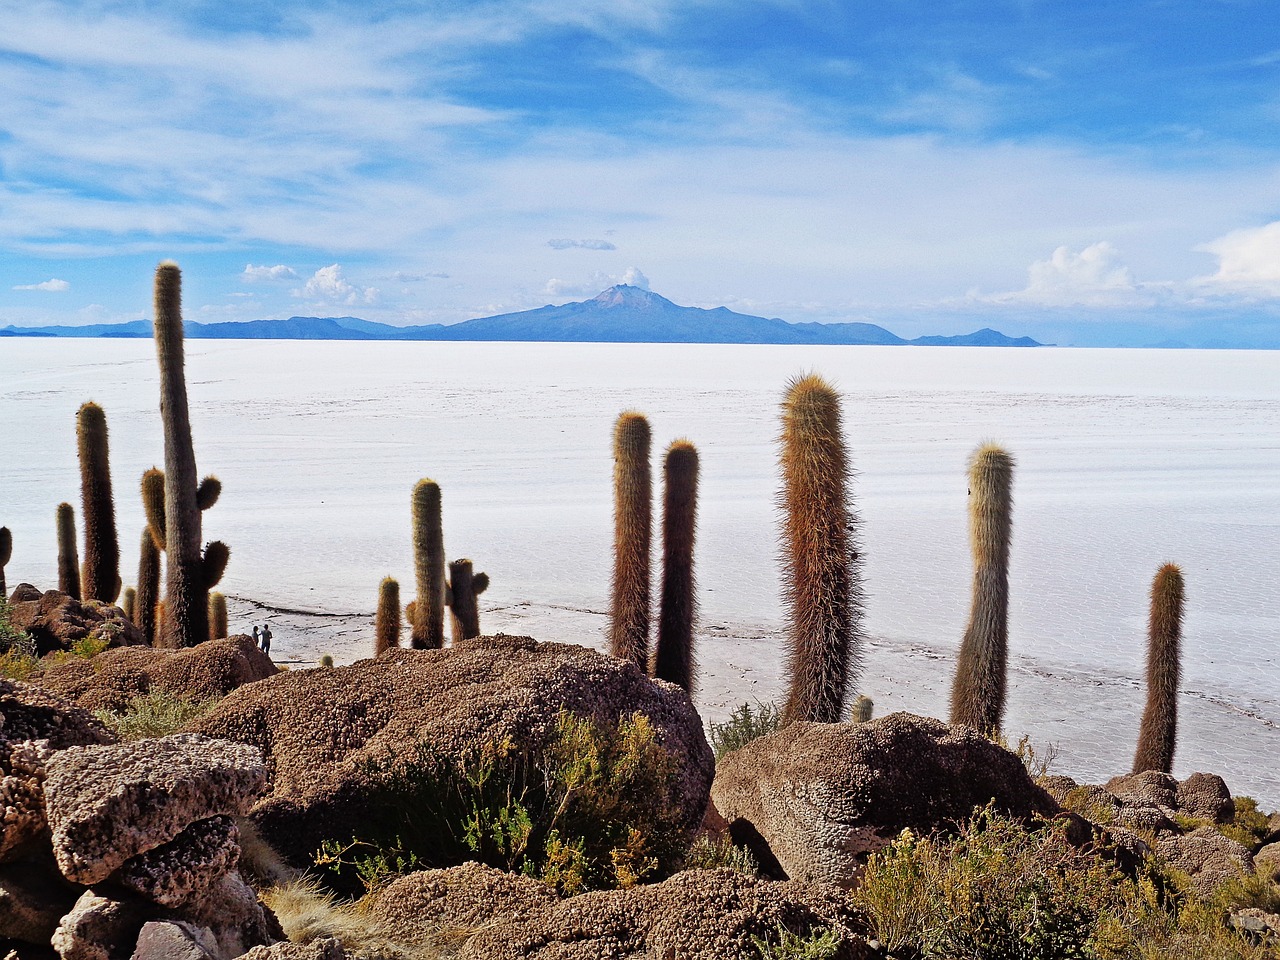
<box><xmin>33</xmin><ymin>635</ymin><xmax>280</xmax><ymax>713</ymax></box>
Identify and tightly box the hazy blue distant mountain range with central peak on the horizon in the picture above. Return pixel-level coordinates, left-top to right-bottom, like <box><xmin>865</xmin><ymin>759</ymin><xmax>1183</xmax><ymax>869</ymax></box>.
<box><xmin>0</xmin><ymin>284</ymin><xmax>1043</xmax><ymax>347</ymax></box>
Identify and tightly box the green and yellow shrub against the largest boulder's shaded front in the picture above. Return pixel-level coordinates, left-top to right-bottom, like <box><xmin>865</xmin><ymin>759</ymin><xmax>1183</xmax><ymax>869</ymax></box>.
<box><xmin>316</xmin><ymin>713</ymin><xmax>686</xmax><ymax>893</ymax></box>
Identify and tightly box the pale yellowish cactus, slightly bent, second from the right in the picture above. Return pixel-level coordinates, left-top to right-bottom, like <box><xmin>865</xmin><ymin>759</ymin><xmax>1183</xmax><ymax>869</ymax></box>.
<box><xmin>951</xmin><ymin>443</ymin><xmax>1014</xmax><ymax>733</ymax></box>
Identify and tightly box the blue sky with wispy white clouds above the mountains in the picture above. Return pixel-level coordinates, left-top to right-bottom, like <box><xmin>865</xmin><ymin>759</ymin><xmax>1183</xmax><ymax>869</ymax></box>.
<box><xmin>0</xmin><ymin>0</ymin><xmax>1280</xmax><ymax>347</ymax></box>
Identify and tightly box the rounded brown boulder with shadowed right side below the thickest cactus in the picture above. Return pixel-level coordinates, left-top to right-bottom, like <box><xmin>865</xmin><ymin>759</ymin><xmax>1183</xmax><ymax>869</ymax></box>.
<box><xmin>712</xmin><ymin>713</ymin><xmax>1060</xmax><ymax>887</ymax></box>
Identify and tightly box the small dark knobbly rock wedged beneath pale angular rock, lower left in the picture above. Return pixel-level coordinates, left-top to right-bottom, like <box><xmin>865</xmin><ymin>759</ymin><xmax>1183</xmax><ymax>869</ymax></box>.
<box><xmin>111</xmin><ymin>817</ymin><xmax>239</xmax><ymax>906</ymax></box>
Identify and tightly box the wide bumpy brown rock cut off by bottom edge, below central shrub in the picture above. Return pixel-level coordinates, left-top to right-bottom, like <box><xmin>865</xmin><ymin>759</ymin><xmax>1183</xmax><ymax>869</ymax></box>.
<box><xmin>458</xmin><ymin>870</ymin><xmax>878</xmax><ymax>960</ymax></box>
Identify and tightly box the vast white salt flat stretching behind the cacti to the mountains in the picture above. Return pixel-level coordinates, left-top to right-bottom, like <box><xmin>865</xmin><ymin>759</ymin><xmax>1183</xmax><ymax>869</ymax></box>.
<box><xmin>0</xmin><ymin>339</ymin><xmax>1280</xmax><ymax>806</ymax></box>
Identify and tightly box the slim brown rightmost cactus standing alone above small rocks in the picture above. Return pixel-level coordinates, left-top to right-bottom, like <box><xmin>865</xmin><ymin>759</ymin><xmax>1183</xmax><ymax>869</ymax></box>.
<box><xmin>1133</xmin><ymin>563</ymin><xmax>1184</xmax><ymax>773</ymax></box>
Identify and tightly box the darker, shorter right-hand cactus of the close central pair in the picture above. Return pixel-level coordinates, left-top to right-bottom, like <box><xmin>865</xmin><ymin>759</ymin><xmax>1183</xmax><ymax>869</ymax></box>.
<box><xmin>653</xmin><ymin>440</ymin><xmax>698</xmax><ymax>695</ymax></box>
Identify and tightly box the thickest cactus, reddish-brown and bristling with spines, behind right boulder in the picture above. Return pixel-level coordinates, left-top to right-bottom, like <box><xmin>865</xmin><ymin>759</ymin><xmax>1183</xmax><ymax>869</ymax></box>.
<box><xmin>781</xmin><ymin>374</ymin><xmax>861</xmax><ymax>723</ymax></box>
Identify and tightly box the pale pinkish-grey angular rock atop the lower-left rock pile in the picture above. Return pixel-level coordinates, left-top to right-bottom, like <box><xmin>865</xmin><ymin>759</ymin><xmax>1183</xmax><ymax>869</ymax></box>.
<box><xmin>45</xmin><ymin>733</ymin><xmax>266</xmax><ymax>884</ymax></box>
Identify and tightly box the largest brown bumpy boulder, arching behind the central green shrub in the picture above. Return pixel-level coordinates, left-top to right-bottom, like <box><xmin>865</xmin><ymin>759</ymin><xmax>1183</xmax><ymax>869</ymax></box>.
<box><xmin>188</xmin><ymin>636</ymin><xmax>714</xmax><ymax>865</ymax></box>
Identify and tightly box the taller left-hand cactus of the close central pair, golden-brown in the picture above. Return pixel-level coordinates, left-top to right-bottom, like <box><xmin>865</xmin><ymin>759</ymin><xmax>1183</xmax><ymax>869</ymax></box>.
<box><xmin>609</xmin><ymin>411</ymin><xmax>653</xmax><ymax>672</ymax></box>
